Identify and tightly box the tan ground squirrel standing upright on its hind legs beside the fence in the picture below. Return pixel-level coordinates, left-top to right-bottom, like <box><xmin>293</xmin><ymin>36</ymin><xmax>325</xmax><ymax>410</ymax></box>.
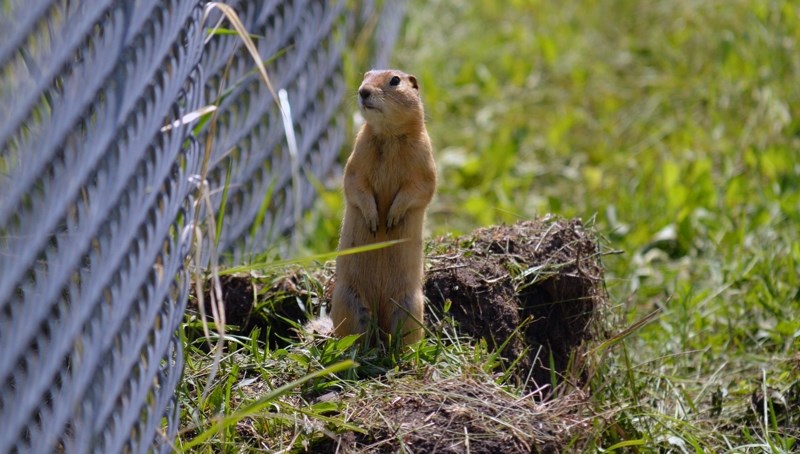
<box><xmin>331</xmin><ymin>70</ymin><xmax>436</xmax><ymax>345</ymax></box>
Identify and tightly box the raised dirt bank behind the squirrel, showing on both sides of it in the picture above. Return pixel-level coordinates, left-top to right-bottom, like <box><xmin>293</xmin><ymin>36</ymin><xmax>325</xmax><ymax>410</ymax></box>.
<box><xmin>191</xmin><ymin>217</ymin><xmax>606</xmax><ymax>389</ymax></box>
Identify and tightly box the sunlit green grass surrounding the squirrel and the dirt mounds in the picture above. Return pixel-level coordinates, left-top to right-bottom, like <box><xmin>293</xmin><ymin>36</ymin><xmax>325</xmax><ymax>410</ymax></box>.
<box><xmin>178</xmin><ymin>0</ymin><xmax>800</xmax><ymax>452</ymax></box>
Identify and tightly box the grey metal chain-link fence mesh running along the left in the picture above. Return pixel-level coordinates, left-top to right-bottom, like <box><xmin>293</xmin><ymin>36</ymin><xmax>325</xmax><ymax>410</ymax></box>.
<box><xmin>0</xmin><ymin>0</ymin><xmax>399</xmax><ymax>453</ymax></box>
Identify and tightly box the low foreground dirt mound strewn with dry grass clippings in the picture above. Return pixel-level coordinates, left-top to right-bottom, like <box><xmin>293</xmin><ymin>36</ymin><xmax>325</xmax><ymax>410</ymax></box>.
<box><xmin>314</xmin><ymin>376</ymin><xmax>586</xmax><ymax>453</ymax></box>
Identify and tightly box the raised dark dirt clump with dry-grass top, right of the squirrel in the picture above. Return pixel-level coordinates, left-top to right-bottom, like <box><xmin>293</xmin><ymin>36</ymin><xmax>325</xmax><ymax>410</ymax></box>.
<box><xmin>425</xmin><ymin>217</ymin><xmax>607</xmax><ymax>389</ymax></box>
